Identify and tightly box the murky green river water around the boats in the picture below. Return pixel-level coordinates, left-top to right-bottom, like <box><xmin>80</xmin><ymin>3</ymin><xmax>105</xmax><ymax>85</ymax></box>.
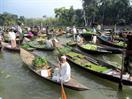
<box><xmin>0</xmin><ymin>35</ymin><xmax>132</xmax><ymax>99</ymax></box>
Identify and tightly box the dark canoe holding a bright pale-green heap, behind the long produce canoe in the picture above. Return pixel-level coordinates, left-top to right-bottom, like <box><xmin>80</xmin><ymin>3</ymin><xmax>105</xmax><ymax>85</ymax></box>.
<box><xmin>78</xmin><ymin>43</ymin><xmax>112</xmax><ymax>54</ymax></box>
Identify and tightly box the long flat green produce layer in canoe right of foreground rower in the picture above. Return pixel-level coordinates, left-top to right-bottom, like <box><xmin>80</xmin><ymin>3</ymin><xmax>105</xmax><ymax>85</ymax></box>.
<box><xmin>66</xmin><ymin>52</ymin><xmax>108</xmax><ymax>72</ymax></box>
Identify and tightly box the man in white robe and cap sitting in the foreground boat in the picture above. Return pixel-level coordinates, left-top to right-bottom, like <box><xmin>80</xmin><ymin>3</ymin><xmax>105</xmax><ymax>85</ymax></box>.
<box><xmin>52</xmin><ymin>56</ymin><xmax>71</xmax><ymax>82</ymax></box>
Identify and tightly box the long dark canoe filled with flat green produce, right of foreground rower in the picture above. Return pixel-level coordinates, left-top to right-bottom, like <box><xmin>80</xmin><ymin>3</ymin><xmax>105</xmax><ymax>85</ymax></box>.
<box><xmin>66</xmin><ymin>51</ymin><xmax>132</xmax><ymax>86</ymax></box>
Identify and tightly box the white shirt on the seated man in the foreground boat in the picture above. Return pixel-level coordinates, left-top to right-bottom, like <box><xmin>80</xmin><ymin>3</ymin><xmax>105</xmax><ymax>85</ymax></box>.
<box><xmin>60</xmin><ymin>62</ymin><xmax>71</xmax><ymax>82</ymax></box>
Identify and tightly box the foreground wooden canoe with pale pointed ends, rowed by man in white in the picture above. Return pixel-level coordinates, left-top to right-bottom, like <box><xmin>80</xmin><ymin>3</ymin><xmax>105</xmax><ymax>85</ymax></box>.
<box><xmin>20</xmin><ymin>49</ymin><xmax>89</xmax><ymax>91</ymax></box>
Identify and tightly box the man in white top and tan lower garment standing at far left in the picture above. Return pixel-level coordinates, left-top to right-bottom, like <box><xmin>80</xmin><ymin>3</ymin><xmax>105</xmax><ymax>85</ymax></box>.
<box><xmin>8</xmin><ymin>28</ymin><xmax>16</xmax><ymax>48</ymax></box>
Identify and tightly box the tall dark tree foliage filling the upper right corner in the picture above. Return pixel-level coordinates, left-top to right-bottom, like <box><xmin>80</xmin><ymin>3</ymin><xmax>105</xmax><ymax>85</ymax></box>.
<box><xmin>83</xmin><ymin>0</ymin><xmax>132</xmax><ymax>25</ymax></box>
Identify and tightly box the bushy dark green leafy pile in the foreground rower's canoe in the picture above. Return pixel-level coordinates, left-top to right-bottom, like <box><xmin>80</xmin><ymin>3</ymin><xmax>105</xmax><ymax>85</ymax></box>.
<box><xmin>32</xmin><ymin>56</ymin><xmax>48</xmax><ymax>70</ymax></box>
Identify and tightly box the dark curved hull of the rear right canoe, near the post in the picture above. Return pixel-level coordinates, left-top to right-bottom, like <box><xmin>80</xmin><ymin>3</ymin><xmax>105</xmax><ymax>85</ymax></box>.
<box><xmin>97</xmin><ymin>36</ymin><xmax>126</xmax><ymax>48</ymax></box>
